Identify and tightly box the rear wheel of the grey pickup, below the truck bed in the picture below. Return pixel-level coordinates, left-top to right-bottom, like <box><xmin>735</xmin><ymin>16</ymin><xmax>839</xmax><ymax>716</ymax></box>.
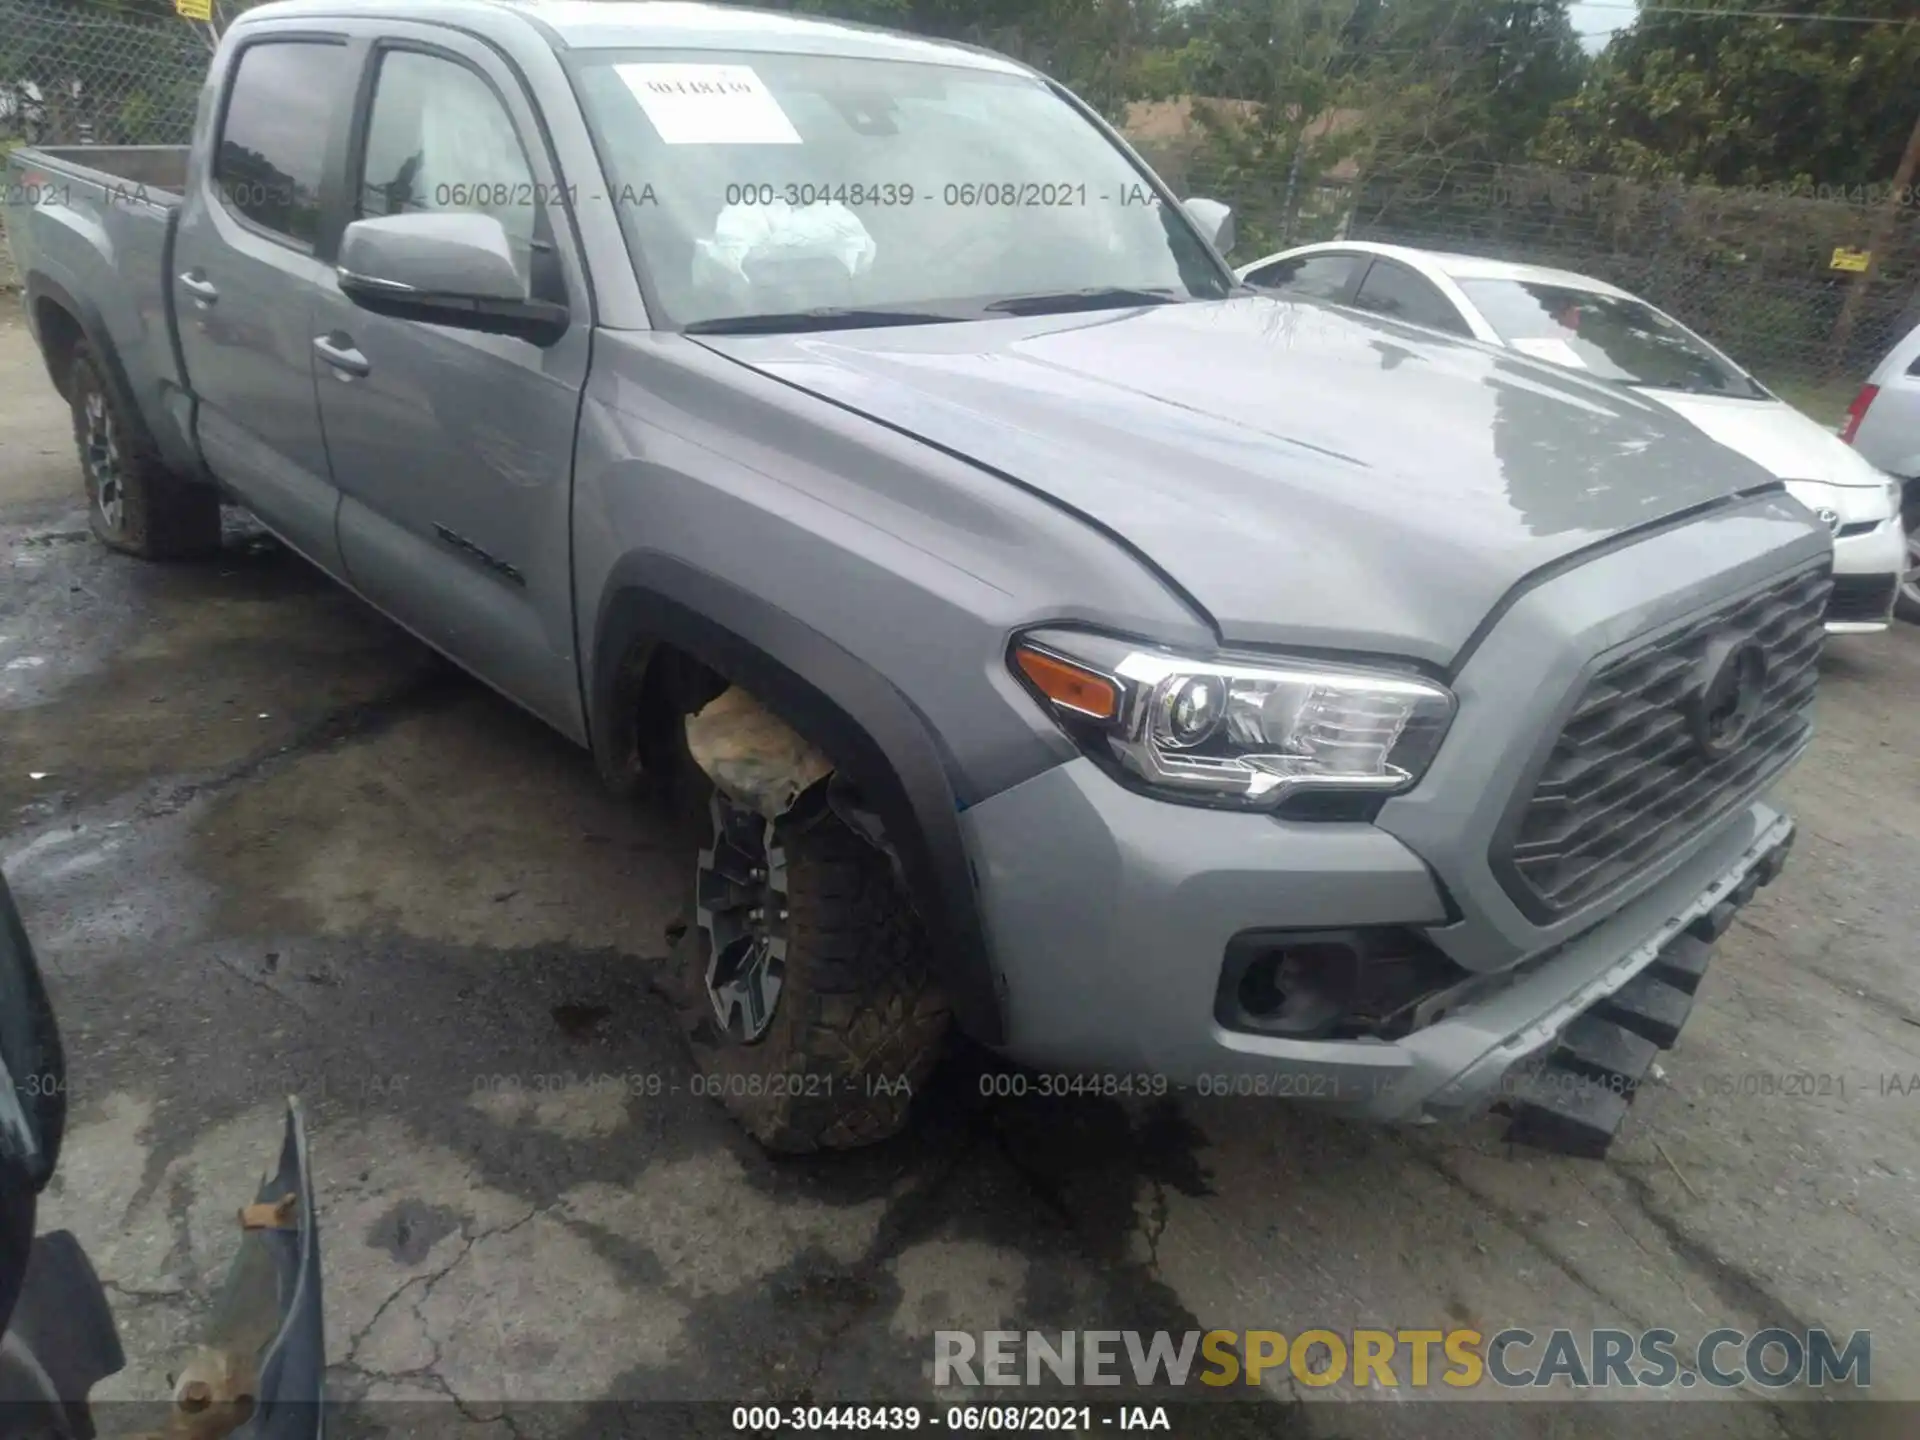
<box><xmin>67</xmin><ymin>340</ymin><xmax>221</xmax><ymax>561</ymax></box>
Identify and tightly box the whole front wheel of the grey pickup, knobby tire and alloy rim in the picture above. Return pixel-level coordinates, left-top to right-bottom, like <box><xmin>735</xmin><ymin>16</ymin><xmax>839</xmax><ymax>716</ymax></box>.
<box><xmin>670</xmin><ymin>791</ymin><xmax>948</xmax><ymax>1152</ymax></box>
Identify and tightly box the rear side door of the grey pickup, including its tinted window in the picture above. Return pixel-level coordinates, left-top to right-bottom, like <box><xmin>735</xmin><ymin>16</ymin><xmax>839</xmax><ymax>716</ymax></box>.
<box><xmin>171</xmin><ymin>31</ymin><xmax>353</xmax><ymax>574</ymax></box>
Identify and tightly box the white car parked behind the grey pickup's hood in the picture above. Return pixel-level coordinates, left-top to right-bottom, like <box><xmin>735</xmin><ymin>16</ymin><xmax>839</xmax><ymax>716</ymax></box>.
<box><xmin>1236</xmin><ymin>240</ymin><xmax>1908</xmax><ymax>634</ymax></box>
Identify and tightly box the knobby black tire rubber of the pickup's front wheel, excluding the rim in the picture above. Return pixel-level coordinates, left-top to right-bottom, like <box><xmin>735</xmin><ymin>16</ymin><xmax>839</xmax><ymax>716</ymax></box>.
<box><xmin>668</xmin><ymin>804</ymin><xmax>948</xmax><ymax>1154</ymax></box>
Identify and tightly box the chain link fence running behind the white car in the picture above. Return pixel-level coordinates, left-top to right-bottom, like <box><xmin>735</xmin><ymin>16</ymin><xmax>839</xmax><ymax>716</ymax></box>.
<box><xmin>1181</xmin><ymin>156</ymin><xmax>1920</xmax><ymax>422</ymax></box>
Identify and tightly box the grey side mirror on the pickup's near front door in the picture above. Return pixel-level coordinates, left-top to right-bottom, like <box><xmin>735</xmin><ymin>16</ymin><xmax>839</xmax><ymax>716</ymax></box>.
<box><xmin>336</xmin><ymin>211</ymin><xmax>570</xmax><ymax>346</ymax></box>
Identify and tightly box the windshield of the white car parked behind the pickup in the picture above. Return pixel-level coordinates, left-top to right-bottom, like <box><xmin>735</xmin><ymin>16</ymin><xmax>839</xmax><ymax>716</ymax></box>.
<box><xmin>1459</xmin><ymin>280</ymin><xmax>1766</xmax><ymax>399</ymax></box>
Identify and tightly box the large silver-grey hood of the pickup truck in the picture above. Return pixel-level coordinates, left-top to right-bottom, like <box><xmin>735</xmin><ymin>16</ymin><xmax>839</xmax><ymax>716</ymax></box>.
<box><xmin>701</xmin><ymin>296</ymin><xmax>1772</xmax><ymax>664</ymax></box>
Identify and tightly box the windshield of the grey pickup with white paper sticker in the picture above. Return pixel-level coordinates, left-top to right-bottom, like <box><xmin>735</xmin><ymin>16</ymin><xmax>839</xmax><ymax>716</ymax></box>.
<box><xmin>578</xmin><ymin>50</ymin><xmax>1233</xmax><ymax>332</ymax></box>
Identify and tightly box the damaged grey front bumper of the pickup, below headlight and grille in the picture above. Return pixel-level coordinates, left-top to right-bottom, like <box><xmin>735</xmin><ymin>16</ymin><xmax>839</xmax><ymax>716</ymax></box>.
<box><xmin>964</xmin><ymin>762</ymin><xmax>1793</xmax><ymax>1154</ymax></box>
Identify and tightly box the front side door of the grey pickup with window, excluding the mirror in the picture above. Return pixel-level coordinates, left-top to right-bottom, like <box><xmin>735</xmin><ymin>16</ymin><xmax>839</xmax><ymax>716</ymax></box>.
<box><xmin>309</xmin><ymin>30</ymin><xmax>591</xmax><ymax>739</ymax></box>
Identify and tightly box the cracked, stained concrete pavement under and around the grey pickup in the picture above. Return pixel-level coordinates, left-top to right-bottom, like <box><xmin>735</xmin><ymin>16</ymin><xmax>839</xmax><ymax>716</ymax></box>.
<box><xmin>0</xmin><ymin>313</ymin><xmax>1920</xmax><ymax>1438</ymax></box>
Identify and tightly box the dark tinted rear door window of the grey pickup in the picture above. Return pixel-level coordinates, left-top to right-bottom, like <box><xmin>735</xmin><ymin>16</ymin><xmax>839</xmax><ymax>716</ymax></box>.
<box><xmin>213</xmin><ymin>40</ymin><xmax>353</xmax><ymax>250</ymax></box>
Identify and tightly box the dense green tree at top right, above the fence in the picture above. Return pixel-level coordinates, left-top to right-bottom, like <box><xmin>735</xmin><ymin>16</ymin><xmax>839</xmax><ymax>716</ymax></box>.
<box><xmin>1536</xmin><ymin>0</ymin><xmax>1920</xmax><ymax>186</ymax></box>
